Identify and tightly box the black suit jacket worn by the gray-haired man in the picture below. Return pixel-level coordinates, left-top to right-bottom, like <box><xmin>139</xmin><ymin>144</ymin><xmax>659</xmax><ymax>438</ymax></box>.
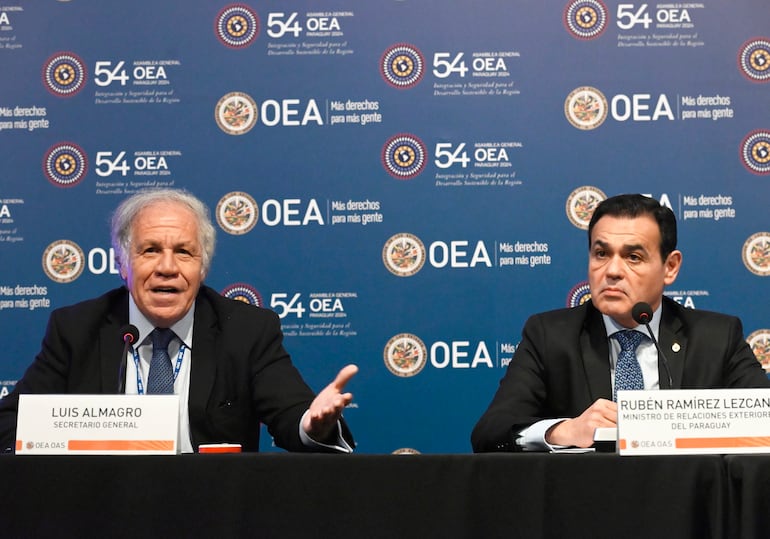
<box><xmin>0</xmin><ymin>286</ymin><xmax>353</xmax><ymax>451</ymax></box>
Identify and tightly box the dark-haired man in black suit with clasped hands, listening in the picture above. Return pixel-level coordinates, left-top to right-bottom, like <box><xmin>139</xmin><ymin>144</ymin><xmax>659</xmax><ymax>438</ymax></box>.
<box><xmin>471</xmin><ymin>195</ymin><xmax>770</xmax><ymax>452</ymax></box>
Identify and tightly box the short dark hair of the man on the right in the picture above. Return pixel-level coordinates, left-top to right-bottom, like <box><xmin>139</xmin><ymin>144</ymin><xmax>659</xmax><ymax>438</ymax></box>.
<box><xmin>588</xmin><ymin>194</ymin><xmax>676</xmax><ymax>261</ymax></box>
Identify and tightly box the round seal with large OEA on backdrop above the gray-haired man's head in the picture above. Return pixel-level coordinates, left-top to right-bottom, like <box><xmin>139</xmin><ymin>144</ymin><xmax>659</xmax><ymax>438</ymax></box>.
<box><xmin>214</xmin><ymin>92</ymin><xmax>324</xmax><ymax>135</ymax></box>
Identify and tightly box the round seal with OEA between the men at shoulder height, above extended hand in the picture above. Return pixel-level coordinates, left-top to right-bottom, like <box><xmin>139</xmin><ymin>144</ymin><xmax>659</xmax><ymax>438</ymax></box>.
<box><xmin>383</xmin><ymin>333</ymin><xmax>494</xmax><ymax>378</ymax></box>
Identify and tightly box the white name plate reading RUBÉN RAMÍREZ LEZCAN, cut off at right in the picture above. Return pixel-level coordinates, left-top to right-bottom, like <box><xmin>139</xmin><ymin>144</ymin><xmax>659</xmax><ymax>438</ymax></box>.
<box><xmin>618</xmin><ymin>389</ymin><xmax>770</xmax><ymax>455</ymax></box>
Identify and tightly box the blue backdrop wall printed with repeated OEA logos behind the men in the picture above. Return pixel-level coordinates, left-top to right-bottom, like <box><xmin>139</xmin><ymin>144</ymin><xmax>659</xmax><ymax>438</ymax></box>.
<box><xmin>0</xmin><ymin>0</ymin><xmax>770</xmax><ymax>453</ymax></box>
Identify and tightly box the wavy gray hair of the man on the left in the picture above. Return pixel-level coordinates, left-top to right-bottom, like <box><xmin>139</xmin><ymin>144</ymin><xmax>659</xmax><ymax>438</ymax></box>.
<box><xmin>110</xmin><ymin>189</ymin><xmax>216</xmax><ymax>276</ymax></box>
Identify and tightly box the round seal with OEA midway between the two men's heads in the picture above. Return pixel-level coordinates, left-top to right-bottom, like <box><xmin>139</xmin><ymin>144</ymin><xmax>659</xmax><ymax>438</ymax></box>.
<box><xmin>382</xmin><ymin>232</ymin><xmax>493</xmax><ymax>277</ymax></box>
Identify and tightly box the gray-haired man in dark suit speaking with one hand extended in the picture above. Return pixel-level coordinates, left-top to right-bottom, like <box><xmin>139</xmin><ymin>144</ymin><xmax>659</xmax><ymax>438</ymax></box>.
<box><xmin>0</xmin><ymin>190</ymin><xmax>357</xmax><ymax>452</ymax></box>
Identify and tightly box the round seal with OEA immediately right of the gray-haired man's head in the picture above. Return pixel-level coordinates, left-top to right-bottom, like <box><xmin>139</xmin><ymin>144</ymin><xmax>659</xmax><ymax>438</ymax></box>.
<box><xmin>216</xmin><ymin>191</ymin><xmax>326</xmax><ymax>230</ymax></box>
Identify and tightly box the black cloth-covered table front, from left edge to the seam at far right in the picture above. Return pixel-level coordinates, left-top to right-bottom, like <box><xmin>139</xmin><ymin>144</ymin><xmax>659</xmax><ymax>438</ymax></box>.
<box><xmin>0</xmin><ymin>454</ymin><xmax>728</xmax><ymax>539</ymax></box>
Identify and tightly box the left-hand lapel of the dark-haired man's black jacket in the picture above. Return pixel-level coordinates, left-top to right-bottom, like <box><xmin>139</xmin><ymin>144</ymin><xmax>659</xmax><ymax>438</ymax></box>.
<box><xmin>580</xmin><ymin>305</ymin><xmax>612</xmax><ymax>402</ymax></box>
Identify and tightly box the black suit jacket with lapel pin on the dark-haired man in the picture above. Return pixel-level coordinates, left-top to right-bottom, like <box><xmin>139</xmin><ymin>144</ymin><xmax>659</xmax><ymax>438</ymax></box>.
<box><xmin>471</xmin><ymin>297</ymin><xmax>770</xmax><ymax>452</ymax></box>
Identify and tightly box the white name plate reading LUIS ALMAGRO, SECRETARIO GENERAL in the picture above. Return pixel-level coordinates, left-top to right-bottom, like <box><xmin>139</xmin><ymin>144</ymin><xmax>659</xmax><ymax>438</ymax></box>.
<box><xmin>16</xmin><ymin>395</ymin><xmax>179</xmax><ymax>455</ymax></box>
